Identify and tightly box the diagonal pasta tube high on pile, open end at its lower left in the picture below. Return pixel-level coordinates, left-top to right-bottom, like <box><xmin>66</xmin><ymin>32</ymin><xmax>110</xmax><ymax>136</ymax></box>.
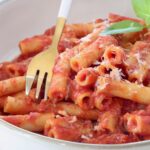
<box><xmin>70</xmin><ymin>36</ymin><xmax>117</xmax><ymax>72</ymax></box>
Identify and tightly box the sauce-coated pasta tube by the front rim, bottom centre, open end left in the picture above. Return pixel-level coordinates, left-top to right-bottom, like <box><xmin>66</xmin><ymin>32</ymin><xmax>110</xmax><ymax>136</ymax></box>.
<box><xmin>44</xmin><ymin>116</ymin><xmax>92</xmax><ymax>141</ymax></box>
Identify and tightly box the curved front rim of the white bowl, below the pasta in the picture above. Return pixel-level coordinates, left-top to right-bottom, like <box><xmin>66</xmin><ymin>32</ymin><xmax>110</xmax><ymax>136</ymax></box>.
<box><xmin>0</xmin><ymin>119</ymin><xmax>150</xmax><ymax>149</ymax></box>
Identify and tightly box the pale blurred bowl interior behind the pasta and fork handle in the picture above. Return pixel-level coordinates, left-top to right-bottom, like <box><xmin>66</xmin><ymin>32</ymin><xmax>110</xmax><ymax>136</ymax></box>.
<box><xmin>0</xmin><ymin>0</ymin><xmax>134</xmax><ymax>61</ymax></box>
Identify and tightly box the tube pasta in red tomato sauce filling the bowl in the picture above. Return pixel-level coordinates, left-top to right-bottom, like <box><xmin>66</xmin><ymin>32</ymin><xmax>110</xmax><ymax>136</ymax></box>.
<box><xmin>0</xmin><ymin>14</ymin><xmax>150</xmax><ymax>144</ymax></box>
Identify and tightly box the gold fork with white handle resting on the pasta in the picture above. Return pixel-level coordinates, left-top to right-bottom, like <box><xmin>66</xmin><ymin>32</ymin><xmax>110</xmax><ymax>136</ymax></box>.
<box><xmin>25</xmin><ymin>0</ymin><xmax>72</xmax><ymax>100</ymax></box>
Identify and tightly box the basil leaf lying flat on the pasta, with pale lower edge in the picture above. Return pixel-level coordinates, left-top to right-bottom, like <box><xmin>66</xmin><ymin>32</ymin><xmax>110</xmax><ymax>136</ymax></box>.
<box><xmin>100</xmin><ymin>20</ymin><xmax>144</xmax><ymax>35</ymax></box>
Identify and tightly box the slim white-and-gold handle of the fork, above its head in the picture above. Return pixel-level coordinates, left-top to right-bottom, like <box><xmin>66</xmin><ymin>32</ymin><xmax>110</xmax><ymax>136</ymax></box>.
<box><xmin>52</xmin><ymin>0</ymin><xmax>72</xmax><ymax>49</ymax></box>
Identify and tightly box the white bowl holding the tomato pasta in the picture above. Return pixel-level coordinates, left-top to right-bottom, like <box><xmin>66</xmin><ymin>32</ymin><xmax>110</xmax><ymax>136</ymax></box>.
<box><xmin>0</xmin><ymin>0</ymin><xmax>150</xmax><ymax>150</ymax></box>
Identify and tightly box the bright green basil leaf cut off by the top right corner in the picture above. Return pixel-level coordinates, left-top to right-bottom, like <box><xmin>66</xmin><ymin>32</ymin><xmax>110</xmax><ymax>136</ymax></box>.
<box><xmin>132</xmin><ymin>0</ymin><xmax>150</xmax><ymax>25</ymax></box>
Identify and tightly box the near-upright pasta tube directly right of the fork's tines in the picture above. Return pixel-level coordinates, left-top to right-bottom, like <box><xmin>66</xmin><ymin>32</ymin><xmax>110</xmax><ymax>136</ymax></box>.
<box><xmin>49</xmin><ymin>50</ymin><xmax>73</xmax><ymax>102</ymax></box>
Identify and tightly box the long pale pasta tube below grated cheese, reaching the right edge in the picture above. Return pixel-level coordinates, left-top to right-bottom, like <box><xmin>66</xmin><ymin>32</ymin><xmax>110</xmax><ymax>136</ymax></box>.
<box><xmin>97</xmin><ymin>76</ymin><xmax>150</xmax><ymax>104</ymax></box>
